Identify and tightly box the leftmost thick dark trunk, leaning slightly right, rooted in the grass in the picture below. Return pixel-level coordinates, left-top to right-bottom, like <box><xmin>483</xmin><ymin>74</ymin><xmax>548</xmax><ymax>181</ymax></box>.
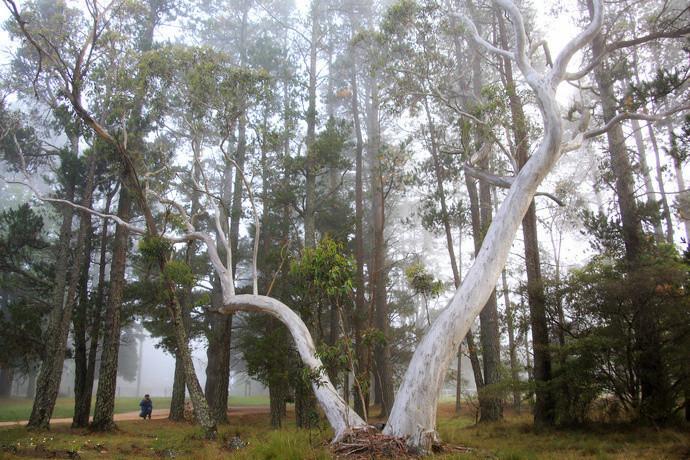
<box><xmin>27</xmin><ymin>177</ymin><xmax>75</xmax><ymax>429</ymax></box>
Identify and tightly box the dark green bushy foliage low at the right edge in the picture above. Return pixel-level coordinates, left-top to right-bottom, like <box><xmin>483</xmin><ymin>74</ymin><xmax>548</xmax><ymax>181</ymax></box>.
<box><xmin>554</xmin><ymin>245</ymin><xmax>690</xmax><ymax>423</ymax></box>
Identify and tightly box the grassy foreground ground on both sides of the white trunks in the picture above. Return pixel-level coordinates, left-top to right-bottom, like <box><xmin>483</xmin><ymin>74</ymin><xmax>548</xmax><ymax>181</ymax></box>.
<box><xmin>0</xmin><ymin>403</ymin><xmax>690</xmax><ymax>460</ymax></box>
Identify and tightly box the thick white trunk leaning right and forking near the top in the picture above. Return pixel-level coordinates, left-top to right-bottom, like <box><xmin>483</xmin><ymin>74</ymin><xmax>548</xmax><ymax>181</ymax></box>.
<box><xmin>384</xmin><ymin>0</ymin><xmax>601</xmax><ymax>451</ymax></box>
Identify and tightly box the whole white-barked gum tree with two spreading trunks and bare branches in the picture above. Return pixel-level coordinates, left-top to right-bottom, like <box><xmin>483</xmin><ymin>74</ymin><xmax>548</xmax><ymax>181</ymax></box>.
<box><xmin>6</xmin><ymin>0</ymin><xmax>688</xmax><ymax>452</ymax></box>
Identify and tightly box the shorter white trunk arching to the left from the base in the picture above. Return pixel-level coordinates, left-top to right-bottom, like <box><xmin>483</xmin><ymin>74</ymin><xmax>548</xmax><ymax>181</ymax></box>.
<box><xmin>219</xmin><ymin>294</ymin><xmax>367</xmax><ymax>441</ymax></box>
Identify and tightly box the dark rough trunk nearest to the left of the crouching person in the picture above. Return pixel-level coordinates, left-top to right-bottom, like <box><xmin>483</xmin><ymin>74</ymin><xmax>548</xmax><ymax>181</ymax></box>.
<box><xmin>91</xmin><ymin>184</ymin><xmax>132</xmax><ymax>431</ymax></box>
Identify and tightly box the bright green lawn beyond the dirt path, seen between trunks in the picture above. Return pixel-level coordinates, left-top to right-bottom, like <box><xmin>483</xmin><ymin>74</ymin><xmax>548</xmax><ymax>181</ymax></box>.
<box><xmin>0</xmin><ymin>396</ymin><xmax>268</xmax><ymax>422</ymax></box>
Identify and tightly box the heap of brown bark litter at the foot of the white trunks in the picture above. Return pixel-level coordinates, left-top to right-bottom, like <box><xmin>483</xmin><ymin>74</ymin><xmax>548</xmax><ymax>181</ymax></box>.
<box><xmin>331</xmin><ymin>427</ymin><xmax>472</xmax><ymax>460</ymax></box>
